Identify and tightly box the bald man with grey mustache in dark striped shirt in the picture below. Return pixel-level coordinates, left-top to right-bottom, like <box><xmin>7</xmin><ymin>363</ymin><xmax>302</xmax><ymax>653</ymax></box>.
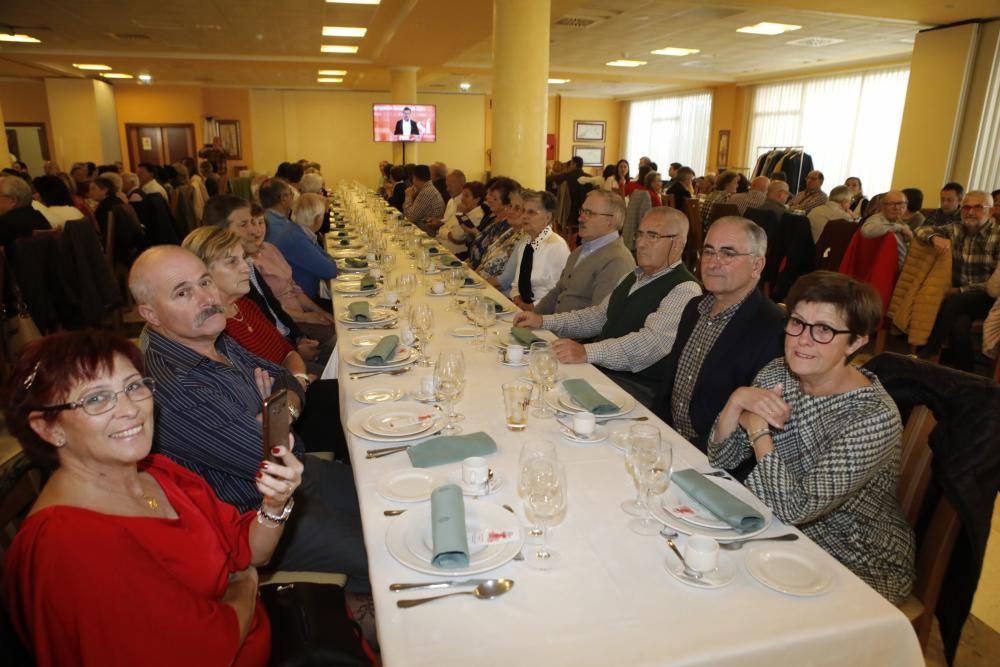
<box><xmin>129</xmin><ymin>245</ymin><xmax>369</xmax><ymax>591</ymax></box>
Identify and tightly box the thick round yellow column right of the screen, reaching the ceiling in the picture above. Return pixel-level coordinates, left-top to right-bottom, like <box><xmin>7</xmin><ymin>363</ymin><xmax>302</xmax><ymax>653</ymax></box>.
<box><xmin>492</xmin><ymin>0</ymin><xmax>552</xmax><ymax>189</ymax></box>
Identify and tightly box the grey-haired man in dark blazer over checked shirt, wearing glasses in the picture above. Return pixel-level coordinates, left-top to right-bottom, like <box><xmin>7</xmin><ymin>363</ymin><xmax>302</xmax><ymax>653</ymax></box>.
<box><xmin>652</xmin><ymin>217</ymin><xmax>784</xmax><ymax>451</ymax></box>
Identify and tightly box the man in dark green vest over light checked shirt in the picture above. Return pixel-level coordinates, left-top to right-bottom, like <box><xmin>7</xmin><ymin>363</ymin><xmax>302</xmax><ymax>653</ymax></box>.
<box><xmin>514</xmin><ymin>206</ymin><xmax>701</xmax><ymax>406</ymax></box>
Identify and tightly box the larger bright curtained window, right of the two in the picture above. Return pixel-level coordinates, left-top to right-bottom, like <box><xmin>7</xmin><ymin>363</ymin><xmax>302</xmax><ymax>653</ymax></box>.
<box><xmin>747</xmin><ymin>67</ymin><xmax>910</xmax><ymax>196</ymax></box>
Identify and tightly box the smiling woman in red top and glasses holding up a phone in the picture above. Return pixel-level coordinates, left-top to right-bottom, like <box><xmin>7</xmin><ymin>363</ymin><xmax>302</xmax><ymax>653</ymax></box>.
<box><xmin>4</xmin><ymin>331</ymin><xmax>302</xmax><ymax>666</ymax></box>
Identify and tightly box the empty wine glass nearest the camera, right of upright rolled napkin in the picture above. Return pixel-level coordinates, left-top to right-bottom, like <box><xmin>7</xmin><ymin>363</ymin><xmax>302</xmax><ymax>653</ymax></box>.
<box><xmin>518</xmin><ymin>458</ymin><xmax>568</xmax><ymax>570</ymax></box>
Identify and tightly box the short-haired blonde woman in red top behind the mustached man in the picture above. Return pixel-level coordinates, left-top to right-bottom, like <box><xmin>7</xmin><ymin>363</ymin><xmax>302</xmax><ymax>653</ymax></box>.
<box><xmin>182</xmin><ymin>227</ymin><xmax>309</xmax><ymax>387</ymax></box>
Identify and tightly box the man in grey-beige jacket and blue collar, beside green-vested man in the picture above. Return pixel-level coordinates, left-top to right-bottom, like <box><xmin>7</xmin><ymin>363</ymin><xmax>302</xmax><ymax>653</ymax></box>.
<box><xmin>534</xmin><ymin>190</ymin><xmax>635</xmax><ymax>315</ymax></box>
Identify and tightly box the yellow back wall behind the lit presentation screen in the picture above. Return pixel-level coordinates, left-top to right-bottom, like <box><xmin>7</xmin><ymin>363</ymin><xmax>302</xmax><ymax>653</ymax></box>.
<box><xmin>250</xmin><ymin>90</ymin><xmax>486</xmax><ymax>185</ymax></box>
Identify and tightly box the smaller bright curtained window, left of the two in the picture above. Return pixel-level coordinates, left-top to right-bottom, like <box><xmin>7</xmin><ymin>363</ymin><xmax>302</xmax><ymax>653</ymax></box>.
<box><xmin>625</xmin><ymin>93</ymin><xmax>712</xmax><ymax>180</ymax></box>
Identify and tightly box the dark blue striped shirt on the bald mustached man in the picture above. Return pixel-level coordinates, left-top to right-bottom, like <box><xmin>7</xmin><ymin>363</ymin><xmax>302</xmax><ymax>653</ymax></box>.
<box><xmin>139</xmin><ymin>327</ymin><xmax>305</xmax><ymax>512</ymax></box>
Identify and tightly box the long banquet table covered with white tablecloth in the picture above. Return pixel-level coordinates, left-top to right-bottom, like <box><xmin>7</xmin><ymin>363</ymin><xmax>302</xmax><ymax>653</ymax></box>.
<box><xmin>324</xmin><ymin>192</ymin><xmax>923</xmax><ymax>667</ymax></box>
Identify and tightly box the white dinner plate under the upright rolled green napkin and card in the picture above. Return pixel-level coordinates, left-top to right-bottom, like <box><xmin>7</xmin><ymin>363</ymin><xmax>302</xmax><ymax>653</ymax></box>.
<box><xmin>385</xmin><ymin>501</ymin><xmax>524</xmax><ymax>577</ymax></box>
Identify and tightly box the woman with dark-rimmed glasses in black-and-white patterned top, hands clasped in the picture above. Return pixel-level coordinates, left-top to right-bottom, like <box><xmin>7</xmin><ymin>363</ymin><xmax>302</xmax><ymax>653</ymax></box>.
<box><xmin>708</xmin><ymin>271</ymin><xmax>915</xmax><ymax>603</ymax></box>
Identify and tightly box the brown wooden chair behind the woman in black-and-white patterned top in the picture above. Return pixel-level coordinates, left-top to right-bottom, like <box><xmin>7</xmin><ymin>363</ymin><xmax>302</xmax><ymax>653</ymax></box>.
<box><xmin>898</xmin><ymin>405</ymin><xmax>961</xmax><ymax>650</ymax></box>
